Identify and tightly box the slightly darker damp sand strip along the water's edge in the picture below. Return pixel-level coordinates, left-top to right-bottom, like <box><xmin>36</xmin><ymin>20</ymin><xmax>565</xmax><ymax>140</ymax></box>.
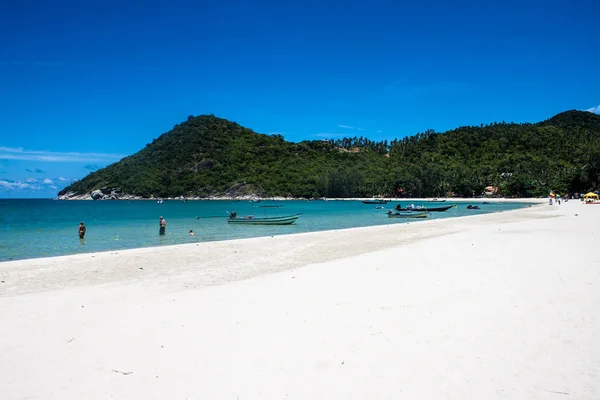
<box><xmin>0</xmin><ymin>203</ymin><xmax>546</xmax><ymax>297</ymax></box>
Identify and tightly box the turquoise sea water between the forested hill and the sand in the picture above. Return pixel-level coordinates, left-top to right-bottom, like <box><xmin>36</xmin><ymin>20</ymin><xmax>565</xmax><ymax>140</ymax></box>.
<box><xmin>0</xmin><ymin>199</ymin><xmax>529</xmax><ymax>261</ymax></box>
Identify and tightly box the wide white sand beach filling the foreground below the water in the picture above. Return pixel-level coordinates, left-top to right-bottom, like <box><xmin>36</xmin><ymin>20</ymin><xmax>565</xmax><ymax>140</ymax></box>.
<box><xmin>0</xmin><ymin>200</ymin><xmax>600</xmax><ymax>400</ymax></box>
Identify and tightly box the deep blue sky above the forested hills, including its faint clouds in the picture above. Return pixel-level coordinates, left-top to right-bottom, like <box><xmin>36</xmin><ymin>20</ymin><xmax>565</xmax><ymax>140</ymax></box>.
<box><xmin>0</xmin><ymin>0</ymin><xmax>600</xmax><ymax>197</ymax></box>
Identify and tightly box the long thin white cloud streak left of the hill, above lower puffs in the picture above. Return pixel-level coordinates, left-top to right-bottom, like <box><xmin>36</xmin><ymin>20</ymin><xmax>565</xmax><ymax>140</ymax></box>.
<box><xmin>0</xmin><ymin>147</ymin><xmax>125</xmax><ymax>162</ymax></box>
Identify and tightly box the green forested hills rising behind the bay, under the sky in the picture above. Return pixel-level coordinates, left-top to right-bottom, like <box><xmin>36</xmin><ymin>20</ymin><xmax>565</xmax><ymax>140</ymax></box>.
<box><xmin>59</xmin><ymin>111</ymin><xmax>600</xmax><ymax>197</ymax></box>
